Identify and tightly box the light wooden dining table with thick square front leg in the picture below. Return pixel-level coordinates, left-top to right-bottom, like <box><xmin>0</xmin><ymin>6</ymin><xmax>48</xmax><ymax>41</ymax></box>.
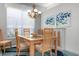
<box><xmin>18</xmin><ymin>35</ymin><xmax>43</xmax><ymax>56</ymax></box>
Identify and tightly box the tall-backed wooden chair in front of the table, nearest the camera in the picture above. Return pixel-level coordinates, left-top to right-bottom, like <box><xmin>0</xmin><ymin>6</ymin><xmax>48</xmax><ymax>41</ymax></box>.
<box><xmin>36</xmin><ymin>30</ymin><xmax>52</xmax><ymax>56</ymax></box>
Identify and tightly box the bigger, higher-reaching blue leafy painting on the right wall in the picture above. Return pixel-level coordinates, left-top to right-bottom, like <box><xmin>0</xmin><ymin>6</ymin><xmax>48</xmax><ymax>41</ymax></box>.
<box><xmin>56</xmin><ymin>12</ymin><xmax>71</xmax><ymax>26</ymax></box>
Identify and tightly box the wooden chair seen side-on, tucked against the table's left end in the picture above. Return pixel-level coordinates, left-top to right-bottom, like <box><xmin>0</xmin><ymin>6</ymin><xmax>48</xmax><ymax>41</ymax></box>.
<box><xmin>15</xmin><ymin>28</ymin><xmax>28</xmax><ymax>56</ymax></box>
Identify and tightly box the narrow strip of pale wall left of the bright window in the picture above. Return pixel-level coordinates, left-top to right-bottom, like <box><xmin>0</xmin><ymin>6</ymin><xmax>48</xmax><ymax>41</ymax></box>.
<box><xmin>0</xmin><ymin>3</ymin><xmax>6</xmax><ymax>38</ymax></box>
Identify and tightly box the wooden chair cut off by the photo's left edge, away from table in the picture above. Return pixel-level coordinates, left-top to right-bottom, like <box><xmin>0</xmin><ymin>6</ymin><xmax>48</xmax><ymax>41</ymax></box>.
<box><xmin>0</xmin><ymin>29</ymin><xmax>12</xmax><ymax>53</ymax></box>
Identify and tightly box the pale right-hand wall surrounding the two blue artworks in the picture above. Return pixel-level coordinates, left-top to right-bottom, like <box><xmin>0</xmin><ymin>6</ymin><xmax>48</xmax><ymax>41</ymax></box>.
<box><xmin>41</xmin><ymin>3</ymin><xmax>79</xmax><ymax>54</ymax></box>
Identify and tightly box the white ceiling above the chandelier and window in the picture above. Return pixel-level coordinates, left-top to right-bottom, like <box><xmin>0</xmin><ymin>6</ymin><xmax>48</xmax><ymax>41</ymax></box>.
<box><xmin>7</xmin><ymin>3</ymin><xmax>59</xmax><ymax>12</ymax></box>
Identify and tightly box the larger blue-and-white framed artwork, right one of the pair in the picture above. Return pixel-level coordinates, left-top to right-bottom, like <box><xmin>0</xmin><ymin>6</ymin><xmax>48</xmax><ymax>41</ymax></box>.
<box><xmin>56</xmin><ymin>12</ymin><xmax>71</xmax><ymax>28</ymax></box>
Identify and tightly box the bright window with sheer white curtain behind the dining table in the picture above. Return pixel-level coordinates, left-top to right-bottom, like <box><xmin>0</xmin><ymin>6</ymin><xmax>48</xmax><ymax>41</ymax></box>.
<box><xmin>7</xmin><ymin>7</ymin><xmax>34</xmax><ymax>38</ymax></box>
